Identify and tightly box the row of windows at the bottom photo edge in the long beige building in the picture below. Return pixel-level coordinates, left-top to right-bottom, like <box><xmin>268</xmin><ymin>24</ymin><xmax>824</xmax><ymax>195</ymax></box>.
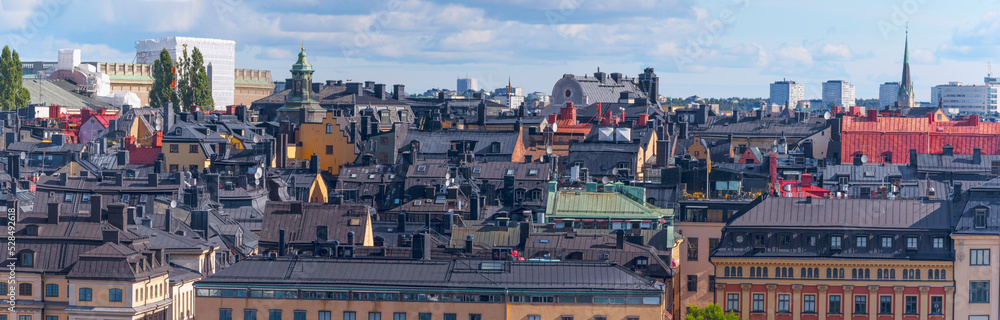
<box><xmin>228</xmin><ymin>308</ymin><xmax>639</xmax><ymax>320</ymax></box>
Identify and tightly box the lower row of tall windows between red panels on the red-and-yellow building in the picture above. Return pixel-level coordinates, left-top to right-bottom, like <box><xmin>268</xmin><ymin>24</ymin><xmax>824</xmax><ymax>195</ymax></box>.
<box><xmin>726</xmin><ymin>293</ymin><xmax>944</xmax><ymax>315</ymax></box>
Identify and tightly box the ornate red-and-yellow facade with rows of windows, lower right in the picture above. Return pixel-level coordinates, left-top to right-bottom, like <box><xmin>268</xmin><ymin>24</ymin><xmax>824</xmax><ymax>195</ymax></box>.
<box><xmin>712</xmin><ymin>257</ymin><xmax>955</xmax><ymax>320</ymax></box>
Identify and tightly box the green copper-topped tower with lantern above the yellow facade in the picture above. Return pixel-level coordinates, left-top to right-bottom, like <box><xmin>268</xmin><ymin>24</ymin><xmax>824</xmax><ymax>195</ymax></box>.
<box><xmin>278</xmin><ymin>45</ymin><xmax>326</xmax><ymax>124</ymax></box>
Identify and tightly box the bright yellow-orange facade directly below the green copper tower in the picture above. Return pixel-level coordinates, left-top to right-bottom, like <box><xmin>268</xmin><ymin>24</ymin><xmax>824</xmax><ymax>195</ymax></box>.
<box><xmin>288</xmin><ymin>112</ymin><xmax>358</xmax><ymax>175</ymax></box>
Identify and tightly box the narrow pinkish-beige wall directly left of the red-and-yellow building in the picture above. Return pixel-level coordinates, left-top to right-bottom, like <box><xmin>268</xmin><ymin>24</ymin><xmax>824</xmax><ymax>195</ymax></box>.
<box><xmin>674</xmin><ymin>222</ymin><xmax>726</xmax><ymax>318</ymax></box>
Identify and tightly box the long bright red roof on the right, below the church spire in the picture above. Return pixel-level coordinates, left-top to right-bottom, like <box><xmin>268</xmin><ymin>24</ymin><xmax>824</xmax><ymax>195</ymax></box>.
<box><xmin>840</xmin><ymin>116</ymin><xmax>1000</xmax><ymax>163</ymax></box>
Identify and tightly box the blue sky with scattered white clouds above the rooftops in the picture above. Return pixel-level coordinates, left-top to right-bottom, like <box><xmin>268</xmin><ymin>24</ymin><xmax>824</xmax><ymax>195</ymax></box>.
<box><xmin>0</xmin><ymin>0</ymin><xmax>1000</xmax><ymax>101</ymax></box>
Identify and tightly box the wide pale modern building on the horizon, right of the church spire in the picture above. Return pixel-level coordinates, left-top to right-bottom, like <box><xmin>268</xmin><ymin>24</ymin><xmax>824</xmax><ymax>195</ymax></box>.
<box><xmin>931</xmin><ymin>80</ymin><xmax>1000</xmax><ymax>114</ymax></box>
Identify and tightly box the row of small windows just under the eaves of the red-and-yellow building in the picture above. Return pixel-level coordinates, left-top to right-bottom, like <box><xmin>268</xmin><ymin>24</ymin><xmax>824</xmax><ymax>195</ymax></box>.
<box><xmin>723</xmin><ymin>267</ymin><xmax>947</xmax><ymax>280</ymax></box>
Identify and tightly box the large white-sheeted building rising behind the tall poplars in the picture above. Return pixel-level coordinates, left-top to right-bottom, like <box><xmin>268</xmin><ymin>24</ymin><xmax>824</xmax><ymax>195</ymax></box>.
<box><xmin>135</xmin><ymin>37</ymin><xmax>236</xmax><ymax>109</ymax></box>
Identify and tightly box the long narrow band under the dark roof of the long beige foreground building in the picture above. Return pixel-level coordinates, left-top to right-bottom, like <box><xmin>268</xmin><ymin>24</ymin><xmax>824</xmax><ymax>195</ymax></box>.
<box><xmin>195</xmin><ymin>289</ymin><xmax>660</xmax><ymax>305</ymax></box>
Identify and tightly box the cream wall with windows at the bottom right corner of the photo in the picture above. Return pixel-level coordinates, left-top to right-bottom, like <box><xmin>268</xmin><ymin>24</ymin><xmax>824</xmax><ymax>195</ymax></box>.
<box><xmin>952</xmin><ymin>234</ymin><xmax>1000</xmax><ymax>319</ymax></box>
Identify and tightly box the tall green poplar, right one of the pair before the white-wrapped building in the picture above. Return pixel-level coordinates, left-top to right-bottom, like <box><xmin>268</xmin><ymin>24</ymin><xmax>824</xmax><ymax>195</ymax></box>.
<box><xmin>177</xmin><ymin>45</ymin><xmax>215</xmax><ymax>110</ymax></box>
